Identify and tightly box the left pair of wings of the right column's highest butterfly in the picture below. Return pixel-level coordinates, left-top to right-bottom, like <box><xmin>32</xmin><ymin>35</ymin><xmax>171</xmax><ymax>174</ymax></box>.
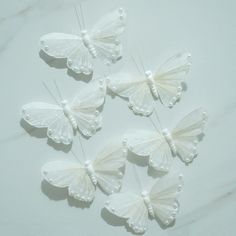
<box><xmin>108</xmin><ymin>73</ymin><xmax>154</xmax><ymax>116</ymax></box>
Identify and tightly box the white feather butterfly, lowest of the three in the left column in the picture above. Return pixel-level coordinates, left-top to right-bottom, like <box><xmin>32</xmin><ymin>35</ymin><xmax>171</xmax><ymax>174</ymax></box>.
<box><xmin>42</xmin><ymin>141</ymin><xmax>127</xmax><ymax>202</ymax></box>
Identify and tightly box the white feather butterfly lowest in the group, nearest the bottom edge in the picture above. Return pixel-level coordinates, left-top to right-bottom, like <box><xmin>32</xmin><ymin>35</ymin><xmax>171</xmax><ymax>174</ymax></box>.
<box><xmin>105</xmin><ymin>174</ymin><xmax>183</xmax><ymax>233</ymax></box>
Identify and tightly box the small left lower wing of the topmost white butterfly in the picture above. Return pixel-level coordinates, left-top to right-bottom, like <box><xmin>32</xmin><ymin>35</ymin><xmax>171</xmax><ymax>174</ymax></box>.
<box><xmin>67</xmin><ymin>44</ymin><xmax>93</xmax><ymax>75</ymax></box>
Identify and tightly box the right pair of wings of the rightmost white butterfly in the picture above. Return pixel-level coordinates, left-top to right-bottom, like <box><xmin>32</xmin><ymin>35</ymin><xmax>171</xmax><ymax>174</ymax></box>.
<box><xmin>172</xmin><ymin>108</ymin><xmax>207</xmax><ymax>163</ymax></box>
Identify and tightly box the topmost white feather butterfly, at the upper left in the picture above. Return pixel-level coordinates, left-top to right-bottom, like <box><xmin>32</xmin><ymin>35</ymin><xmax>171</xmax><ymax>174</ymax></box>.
<box><xmin>40</xmin><ymin>8</ymin><xmax>126</xmax><ymax>74</ymax></box>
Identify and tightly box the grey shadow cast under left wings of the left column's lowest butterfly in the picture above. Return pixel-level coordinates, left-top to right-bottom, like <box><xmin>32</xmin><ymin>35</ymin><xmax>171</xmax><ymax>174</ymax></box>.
<box><xmin>41</xmin><ymin>180</ymin><xmax>91</xmax><ymax>209</ymax></box>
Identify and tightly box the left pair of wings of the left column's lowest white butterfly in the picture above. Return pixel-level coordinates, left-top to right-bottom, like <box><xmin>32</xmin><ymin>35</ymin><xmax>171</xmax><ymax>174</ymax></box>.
<box><xmin>42</xmin><ymin>161</ymin><xmax>95</xmax><ymax>202</ymax></box>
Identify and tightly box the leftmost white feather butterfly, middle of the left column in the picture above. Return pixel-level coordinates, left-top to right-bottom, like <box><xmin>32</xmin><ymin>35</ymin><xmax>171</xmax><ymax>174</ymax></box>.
<box><xmin>22</xmin><ymin>79</ymin><xmax>106</xmax><ymax>145</ymax></box>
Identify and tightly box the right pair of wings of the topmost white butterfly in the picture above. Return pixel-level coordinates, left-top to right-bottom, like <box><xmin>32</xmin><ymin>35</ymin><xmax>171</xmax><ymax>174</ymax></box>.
<box><xmin>90</xmin><ymin>8</ymin><xmax>126</xmax><ymax>63</ymax></box>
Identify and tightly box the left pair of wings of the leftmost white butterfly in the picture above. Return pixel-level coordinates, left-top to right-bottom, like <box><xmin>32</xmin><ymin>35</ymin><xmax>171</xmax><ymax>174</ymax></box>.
<box><xmin>22</xmin><ymin>102</ymin><xmax>73</xmax><ymax>145</ymax></box>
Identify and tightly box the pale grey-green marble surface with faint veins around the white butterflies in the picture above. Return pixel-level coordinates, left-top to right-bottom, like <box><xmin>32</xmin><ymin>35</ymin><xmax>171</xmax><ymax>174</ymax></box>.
<box><xmin>0</xmin><ymin>0</ymin><xmax>236</xmax><ymax>236</ymax></box>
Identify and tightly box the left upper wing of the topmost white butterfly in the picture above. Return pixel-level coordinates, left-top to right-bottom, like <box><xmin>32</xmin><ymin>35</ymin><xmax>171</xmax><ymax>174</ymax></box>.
<box><xmin>40</xmin><ymin>33</ymin><xmax>81</xmax><ymax>58</ymax></box>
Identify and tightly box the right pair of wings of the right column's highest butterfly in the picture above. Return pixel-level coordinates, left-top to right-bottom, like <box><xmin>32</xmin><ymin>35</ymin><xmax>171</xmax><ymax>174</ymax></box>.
<box><xmin>154</xmin><ymin>53</ymin><xmax>191</xmax><ymax>107</ymax></box>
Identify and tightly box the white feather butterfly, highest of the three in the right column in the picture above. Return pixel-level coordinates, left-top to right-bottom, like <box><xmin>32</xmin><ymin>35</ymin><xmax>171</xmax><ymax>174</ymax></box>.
<box><xmin>108</xmin><ymin>53</ymin><xmax>191</xmax><ymax>116</ymax></box>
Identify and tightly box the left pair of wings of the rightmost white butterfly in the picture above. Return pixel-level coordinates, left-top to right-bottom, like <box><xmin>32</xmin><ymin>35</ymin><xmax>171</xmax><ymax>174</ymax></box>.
<box><xmin>125</xmin><ymin>130</ymin><xmax>172</xmax><ymax>172</ymax></box>
